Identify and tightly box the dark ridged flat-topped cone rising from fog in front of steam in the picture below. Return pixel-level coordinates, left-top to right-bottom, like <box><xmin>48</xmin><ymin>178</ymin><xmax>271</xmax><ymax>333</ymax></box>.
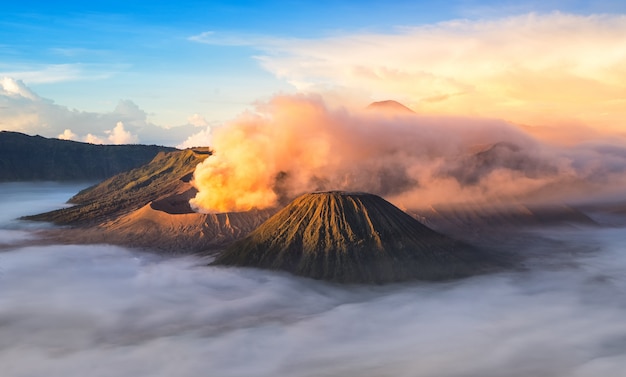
<box><xmin>212</xmin><ymin>192</ymin><xmax>501</xmax><ymax>283</ymax></box>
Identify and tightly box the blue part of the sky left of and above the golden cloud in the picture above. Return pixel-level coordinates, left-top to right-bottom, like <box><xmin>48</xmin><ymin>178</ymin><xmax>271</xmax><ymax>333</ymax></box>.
<box><xmin>0</xmin><ymin>0</ymin><xmax>626</xmax><ymax>145</ymax></box>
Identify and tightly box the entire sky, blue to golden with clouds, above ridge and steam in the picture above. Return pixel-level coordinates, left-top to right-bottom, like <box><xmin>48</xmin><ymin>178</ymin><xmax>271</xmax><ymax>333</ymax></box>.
<box><xmin>0</xmin><ymin>0</ymin><xmax>626</xmax><ymax>146</ymax></box>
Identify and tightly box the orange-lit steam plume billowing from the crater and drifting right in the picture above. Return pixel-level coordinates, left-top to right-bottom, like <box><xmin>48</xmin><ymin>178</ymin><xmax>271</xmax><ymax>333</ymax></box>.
<box><xmin>191</xmin><ymin>95</ymin><xmax>626</xmax><ymax>212</ymax></box>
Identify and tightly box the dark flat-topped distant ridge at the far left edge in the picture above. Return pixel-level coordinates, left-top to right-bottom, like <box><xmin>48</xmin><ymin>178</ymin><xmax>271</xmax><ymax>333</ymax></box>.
<box><xmin>0</xmin><ymin>131</ymin><xmax>176</xmax><ymax>182</ymax></box>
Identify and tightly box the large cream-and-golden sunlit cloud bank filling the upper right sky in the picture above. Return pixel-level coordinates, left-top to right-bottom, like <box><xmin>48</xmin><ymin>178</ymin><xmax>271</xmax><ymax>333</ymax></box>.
<box><xmin>224</xmin><ymin>12</ymin><xmax>626</xmax><ymax>141</ymax></box>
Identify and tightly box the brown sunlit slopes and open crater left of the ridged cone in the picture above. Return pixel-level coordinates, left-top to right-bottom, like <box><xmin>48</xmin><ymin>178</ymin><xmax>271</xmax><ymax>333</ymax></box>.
<box><xmin>25</xmin><ymin>148</ymin><xmax>275</xmax><ymax>254</ymax></box>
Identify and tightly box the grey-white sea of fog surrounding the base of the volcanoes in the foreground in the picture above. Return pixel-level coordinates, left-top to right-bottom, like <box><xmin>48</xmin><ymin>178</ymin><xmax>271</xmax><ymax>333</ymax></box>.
<box><xmin>0</xmin><ymin>183</ymin><xmax>626</xmax><ymax>377</ymax></box>
